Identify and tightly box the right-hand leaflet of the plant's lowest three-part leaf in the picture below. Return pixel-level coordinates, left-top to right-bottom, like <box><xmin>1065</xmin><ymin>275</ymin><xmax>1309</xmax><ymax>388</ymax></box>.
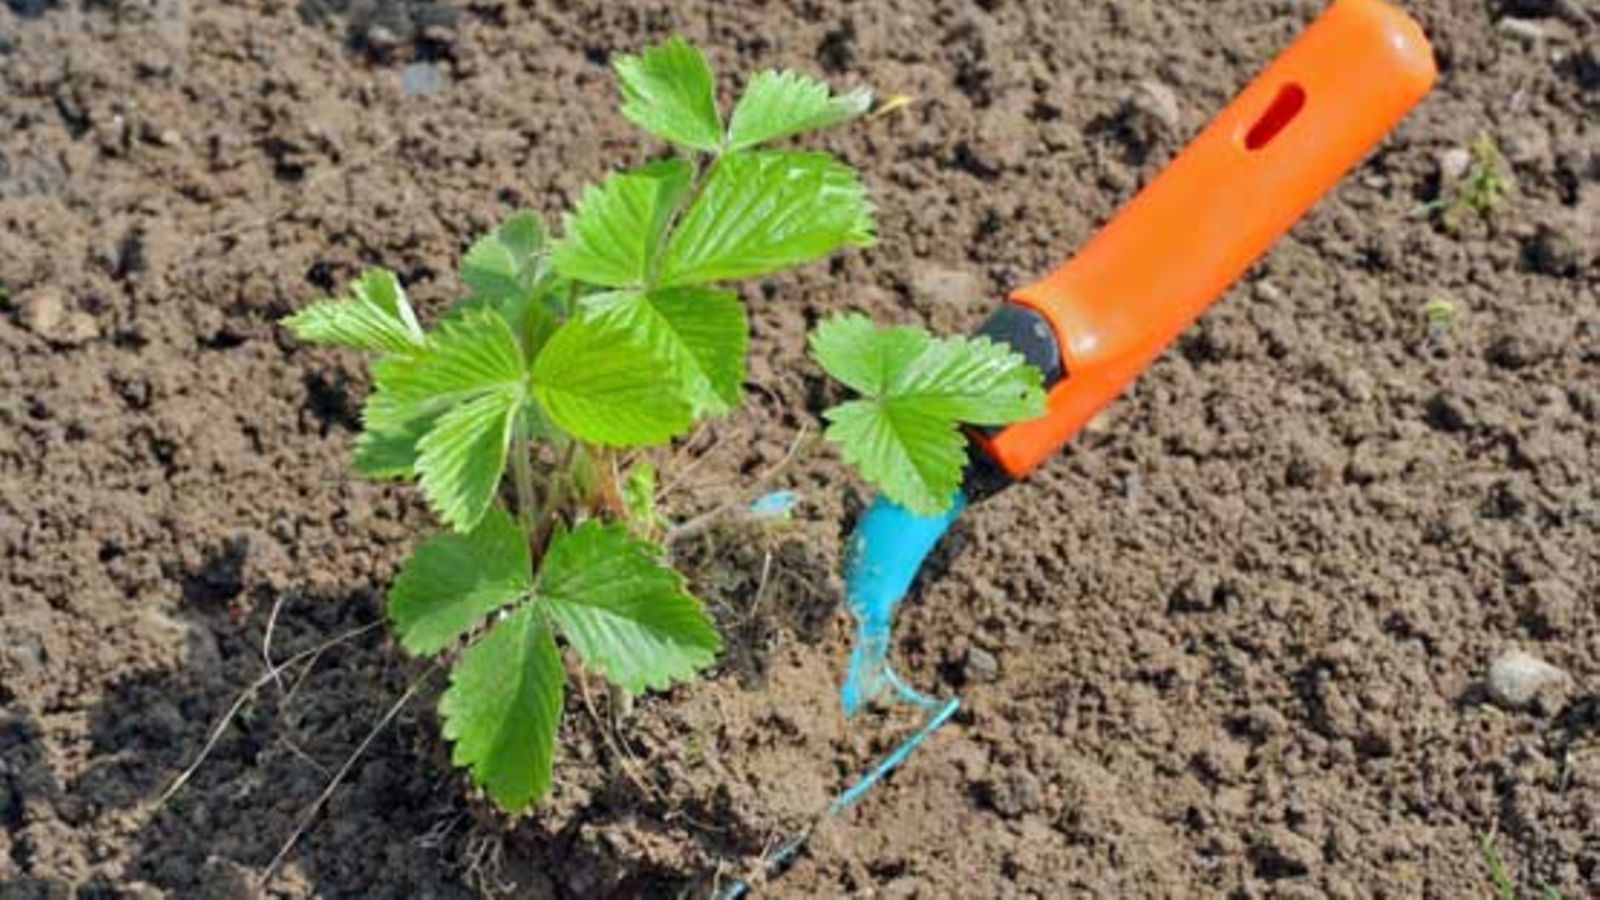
<box><xmin>534</xmin><ymin>520</ymin><xmax>722</xmax><ymax>693</ymax></box>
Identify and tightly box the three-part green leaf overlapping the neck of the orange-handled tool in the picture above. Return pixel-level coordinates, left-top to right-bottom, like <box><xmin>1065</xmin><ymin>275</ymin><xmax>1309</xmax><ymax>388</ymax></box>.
<box><xmin>811</xmin><ymin>315</ymin><xmax>1045</xmax><ymax>514</ymax></box>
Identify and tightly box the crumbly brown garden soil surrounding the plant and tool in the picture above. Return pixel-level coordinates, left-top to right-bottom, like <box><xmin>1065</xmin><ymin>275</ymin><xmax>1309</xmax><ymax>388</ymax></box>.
<box><xmin>0</xmin><ymin>0</ymin><xmax>1600</xmax><ymax>898</ymax></box>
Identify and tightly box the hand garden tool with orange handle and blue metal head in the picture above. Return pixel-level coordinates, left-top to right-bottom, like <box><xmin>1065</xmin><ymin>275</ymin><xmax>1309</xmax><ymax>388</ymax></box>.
<box><xmin>715</xmin><ymin>0</ymin><xmax>1435</xmax><ymax>898</ymax></box>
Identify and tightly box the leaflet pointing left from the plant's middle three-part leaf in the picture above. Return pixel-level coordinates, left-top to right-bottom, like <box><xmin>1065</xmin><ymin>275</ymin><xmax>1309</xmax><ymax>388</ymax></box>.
<box><xmin>362</xmin><ymin>309</ymin><xmax>525</xmax><ymax>431</ymax></box>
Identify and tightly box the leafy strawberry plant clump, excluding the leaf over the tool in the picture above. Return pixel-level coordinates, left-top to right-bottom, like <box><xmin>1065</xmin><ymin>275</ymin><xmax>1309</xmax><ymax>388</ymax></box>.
<box><xmin>283</xmin><ymin>38</ymin><xmax>874</xmax><ymax>812</ymax></box>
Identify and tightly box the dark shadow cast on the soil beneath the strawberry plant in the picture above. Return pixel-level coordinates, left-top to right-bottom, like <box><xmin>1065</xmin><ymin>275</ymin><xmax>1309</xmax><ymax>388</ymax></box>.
<box><xmin>34</xmin><ymin>524</ymin><xmax>837</xmax><ymax>900</ymax></box>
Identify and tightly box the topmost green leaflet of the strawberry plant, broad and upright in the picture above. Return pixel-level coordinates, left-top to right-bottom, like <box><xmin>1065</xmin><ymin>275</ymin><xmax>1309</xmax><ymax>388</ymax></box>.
<box><xmin>611</xmin><ymin>37</ymin><xmax>722</xmax><ymax>152</ymax></box>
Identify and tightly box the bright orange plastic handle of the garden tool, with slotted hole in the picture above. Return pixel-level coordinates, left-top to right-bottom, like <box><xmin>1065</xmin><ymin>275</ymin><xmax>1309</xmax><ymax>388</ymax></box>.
<box><xmin>978</xmin><ymin>0</ymin><xmax>1435</xmax><ymax>477</ymax></box>
